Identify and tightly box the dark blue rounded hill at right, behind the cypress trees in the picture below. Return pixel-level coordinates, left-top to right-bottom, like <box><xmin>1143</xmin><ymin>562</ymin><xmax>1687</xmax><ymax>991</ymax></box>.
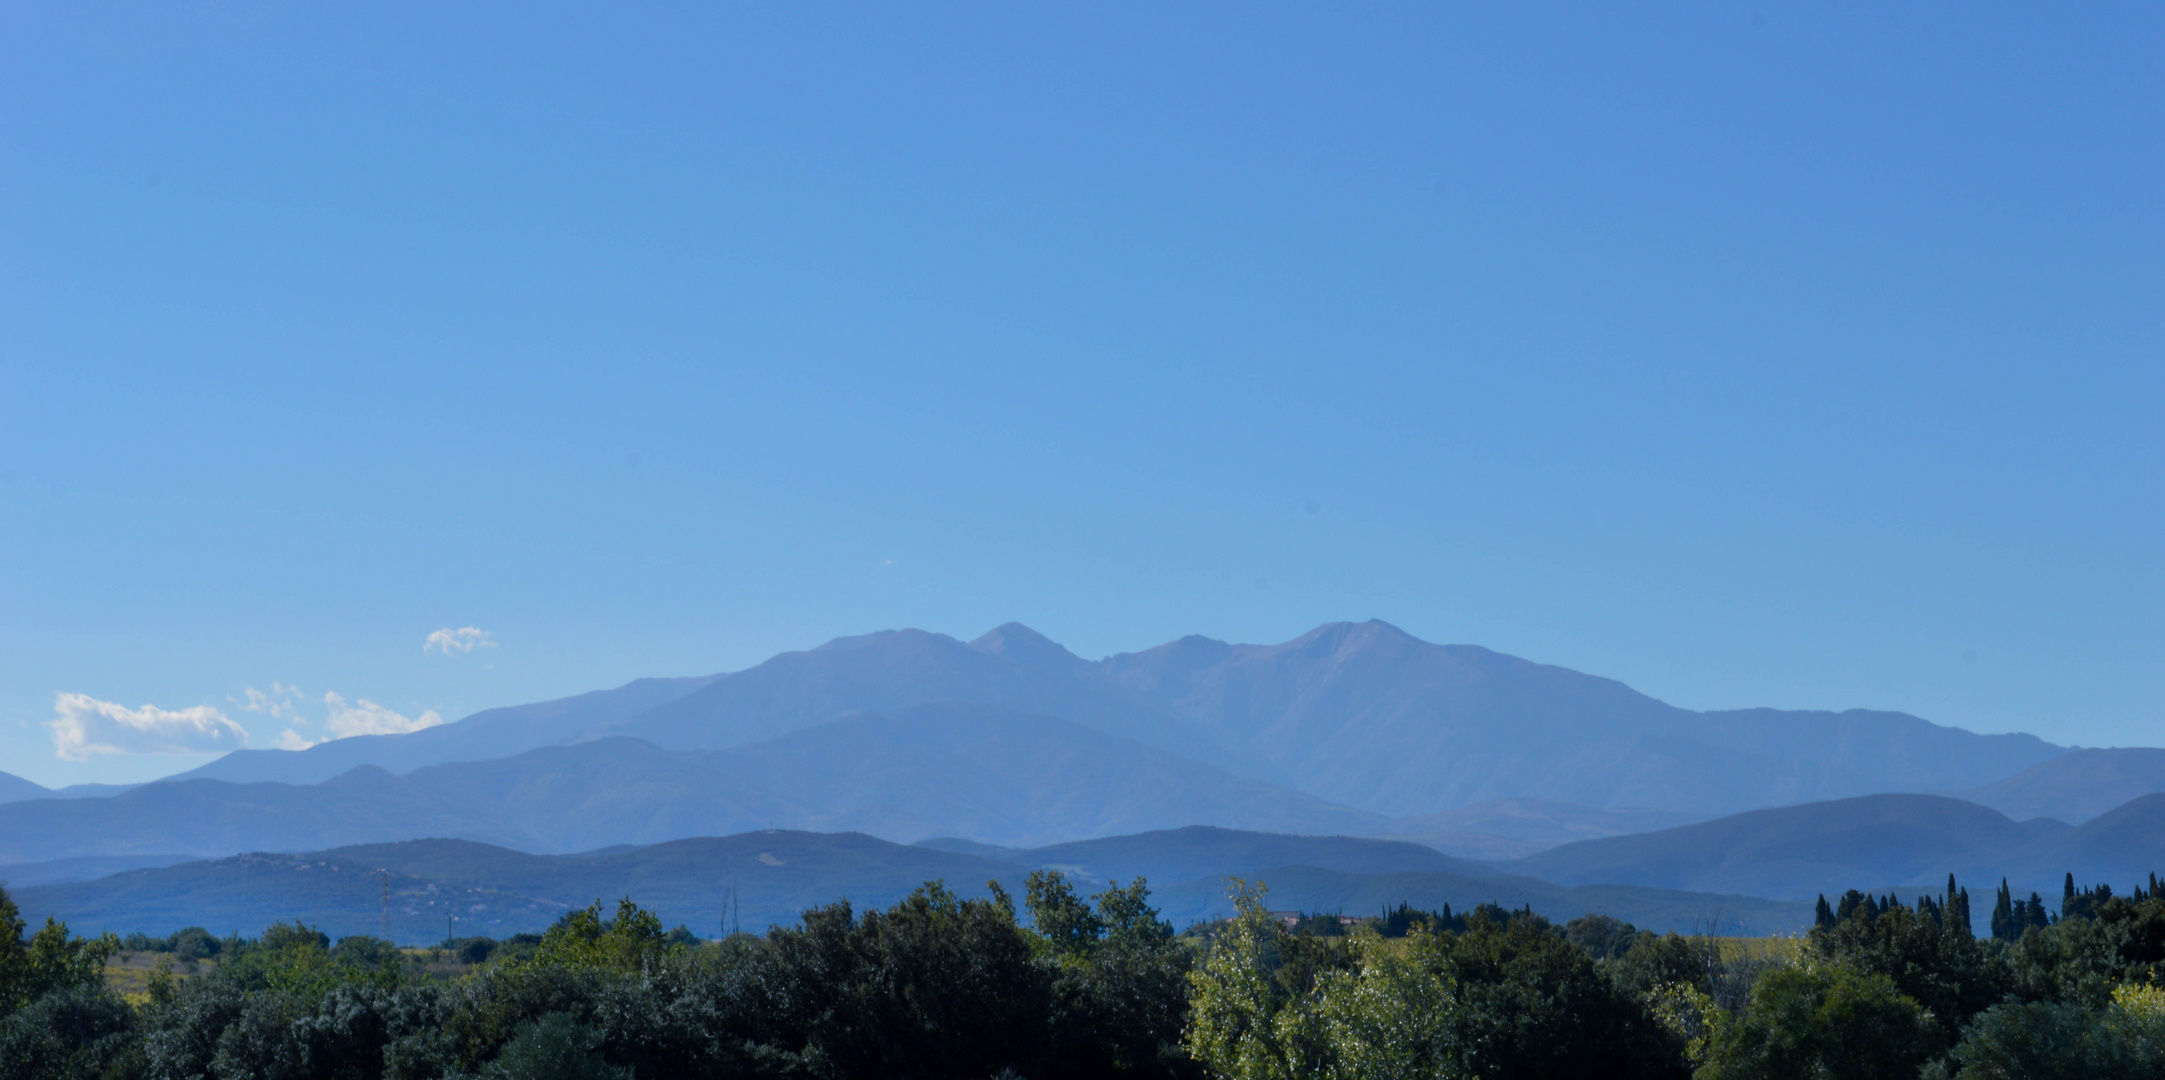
<box><xmin>1505</xmin><ymin>794</ymin><xmax>2065</xmax><ymax>900</ymax></box>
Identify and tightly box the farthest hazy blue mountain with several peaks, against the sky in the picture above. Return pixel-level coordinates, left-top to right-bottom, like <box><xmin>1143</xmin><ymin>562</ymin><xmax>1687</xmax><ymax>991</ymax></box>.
<box><xmin>148</xmin><ymin>621</ymin><xmax>2061</xmax><ymax>818</ymax></box>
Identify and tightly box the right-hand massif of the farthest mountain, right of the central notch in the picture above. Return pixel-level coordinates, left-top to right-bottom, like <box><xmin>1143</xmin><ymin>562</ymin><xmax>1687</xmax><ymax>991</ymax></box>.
<box><xmin>1100</xmin><ymin>621</ymin><xmax>2059</xmax><ymax>816</ymax></box>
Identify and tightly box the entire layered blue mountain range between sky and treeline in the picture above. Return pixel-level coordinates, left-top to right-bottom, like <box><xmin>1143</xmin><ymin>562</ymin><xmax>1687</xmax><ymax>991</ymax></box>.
<box><xmin>0</xmin><ymin>621</ymin><xmax>2165</xmax><ymax>943</ymax></box>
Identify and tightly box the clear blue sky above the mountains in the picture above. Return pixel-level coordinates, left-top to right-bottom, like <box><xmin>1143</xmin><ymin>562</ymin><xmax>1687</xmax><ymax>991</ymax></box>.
<box><xmin>0</xmin><ymin>2</ymin><xmax>2165</xmax><ymax>783</ymax></box>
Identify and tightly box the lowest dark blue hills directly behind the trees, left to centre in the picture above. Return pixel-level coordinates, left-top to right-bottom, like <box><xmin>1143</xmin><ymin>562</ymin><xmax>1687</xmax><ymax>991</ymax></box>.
<box><xmin>15</xmin><ymin>829</ymin><xmax>1810</xmax><ymax>944</ymax></box>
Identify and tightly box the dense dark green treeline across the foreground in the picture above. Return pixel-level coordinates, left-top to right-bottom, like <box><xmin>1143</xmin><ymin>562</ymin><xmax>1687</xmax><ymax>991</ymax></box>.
<box><xmin>0</xmin><ymin>872</ymin><xmax>2165</xmax><ymax>1080</ymax></box>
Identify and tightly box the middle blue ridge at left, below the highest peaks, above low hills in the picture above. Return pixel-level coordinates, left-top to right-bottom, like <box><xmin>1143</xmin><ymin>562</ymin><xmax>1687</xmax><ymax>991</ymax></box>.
<box><xmin>0</xmin><ymin>703</ymin><xmax>1383</xmax><ymax>864</ymax></box>
